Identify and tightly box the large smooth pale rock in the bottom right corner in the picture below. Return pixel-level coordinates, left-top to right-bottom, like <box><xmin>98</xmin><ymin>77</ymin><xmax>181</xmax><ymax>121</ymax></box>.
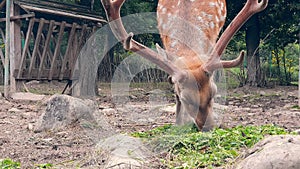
<box><xmin>235</xmin><ymin>135</ymin><xmax>300</xmax><ymax>169</ymax></box>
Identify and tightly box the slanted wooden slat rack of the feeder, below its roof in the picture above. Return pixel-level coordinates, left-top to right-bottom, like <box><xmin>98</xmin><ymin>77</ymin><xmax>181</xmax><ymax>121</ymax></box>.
<box><xmin>13</xmin><ymin>18</ymin><xmax>96</xmax><ymax>80</ymax></box>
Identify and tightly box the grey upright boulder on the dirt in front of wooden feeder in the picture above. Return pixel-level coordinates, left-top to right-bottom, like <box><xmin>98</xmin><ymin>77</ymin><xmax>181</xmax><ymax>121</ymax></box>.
<box><xmin>35</xmin><ymin>95</ymin><xmax>95</xmax><ymax>132</ymax></box>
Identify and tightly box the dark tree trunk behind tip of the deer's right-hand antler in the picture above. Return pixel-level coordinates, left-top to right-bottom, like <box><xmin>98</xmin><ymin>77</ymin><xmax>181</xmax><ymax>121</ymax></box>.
<box><xmin>246</xmin><ymin>15</ymin><xmax>264</xmax><ymax>86</ymax></box>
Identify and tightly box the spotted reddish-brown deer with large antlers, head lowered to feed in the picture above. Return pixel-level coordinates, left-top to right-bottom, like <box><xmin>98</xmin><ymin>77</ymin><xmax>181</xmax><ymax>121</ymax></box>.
<box><xmin>101</xmin><ymin>0</ymin><xmax>268</xmax><ymax>131</ymax></box>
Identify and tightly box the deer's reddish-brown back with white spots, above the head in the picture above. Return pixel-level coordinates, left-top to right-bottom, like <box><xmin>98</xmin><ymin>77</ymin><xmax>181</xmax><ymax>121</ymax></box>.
<box><xmin>157</xmin><ymin>0</ymin><xmax>226</xmax><ymax>69</ymax></box>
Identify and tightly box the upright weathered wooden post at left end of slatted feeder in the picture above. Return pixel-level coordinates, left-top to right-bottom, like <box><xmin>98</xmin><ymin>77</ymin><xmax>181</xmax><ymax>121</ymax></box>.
<box><xmin>10</xmin><ymin>0</ymin><xmax>22</xmax><ymax>93</ymax></box>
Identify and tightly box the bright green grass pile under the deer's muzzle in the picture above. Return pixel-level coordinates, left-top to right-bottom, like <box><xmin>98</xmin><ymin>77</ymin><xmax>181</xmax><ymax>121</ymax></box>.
<box><xmin>132</xmin><ymin>125</ymin><xmax>287</xmax><ymax>169</ymax></box>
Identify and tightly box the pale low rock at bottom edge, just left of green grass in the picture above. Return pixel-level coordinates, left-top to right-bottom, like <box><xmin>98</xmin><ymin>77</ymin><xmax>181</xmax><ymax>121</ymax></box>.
<box><xmin>96</xmin><ymin>134</ymin><xmax>152</xmax><ymax>169</ymax></box>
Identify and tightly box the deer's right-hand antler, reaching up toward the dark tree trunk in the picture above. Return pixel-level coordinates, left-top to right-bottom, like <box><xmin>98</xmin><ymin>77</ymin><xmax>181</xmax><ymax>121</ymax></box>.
<box><xmin>202</xmin><ymin>0</ymin><xmax>268</xmax><ymax>73</ymax></box>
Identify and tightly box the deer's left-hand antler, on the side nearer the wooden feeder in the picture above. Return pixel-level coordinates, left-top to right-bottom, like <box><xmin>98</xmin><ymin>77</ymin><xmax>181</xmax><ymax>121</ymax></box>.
<box><xmin>101</xmin><ymin>0</ymin><xmax>187</xmax><ymax>82</ymax></box>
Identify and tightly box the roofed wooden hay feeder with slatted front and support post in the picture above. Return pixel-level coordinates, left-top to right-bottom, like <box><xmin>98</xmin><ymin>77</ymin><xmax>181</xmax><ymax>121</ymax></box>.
<box><xmin>0</xmin><ymin>0</ymin><xmax>107</xmax><ymax>93</ymax></box>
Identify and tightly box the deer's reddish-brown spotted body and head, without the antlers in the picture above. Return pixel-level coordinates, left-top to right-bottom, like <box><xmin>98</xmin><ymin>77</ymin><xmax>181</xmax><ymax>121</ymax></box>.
<box><xmin>157</xmin><ymin>0</ymin><xmax>226</xmax><ymax>129</ymax></box>
